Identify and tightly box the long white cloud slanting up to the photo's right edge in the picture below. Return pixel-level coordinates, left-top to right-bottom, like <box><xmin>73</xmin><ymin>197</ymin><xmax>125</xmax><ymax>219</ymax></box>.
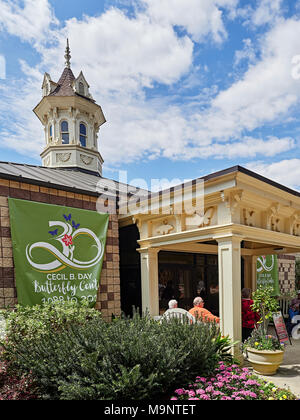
<box><xmin>188</xmin><ymin>19</ymin><xmax>300</xmax><ymax>141</ymax></box>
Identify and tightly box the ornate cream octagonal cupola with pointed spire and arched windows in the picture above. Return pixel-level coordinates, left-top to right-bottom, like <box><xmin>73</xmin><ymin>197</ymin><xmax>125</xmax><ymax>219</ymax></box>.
<box><xmin>34</xmin><ymin>41</ymin><xmax>106</xmax><ymax>176</ymax></box>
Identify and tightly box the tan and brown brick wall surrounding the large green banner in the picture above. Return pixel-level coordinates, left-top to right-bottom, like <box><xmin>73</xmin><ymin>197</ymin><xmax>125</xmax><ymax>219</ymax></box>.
<box><xmin>0</xmin><ymin>179</ymin><xmax>121</xmax><ymax>320</ymax></box>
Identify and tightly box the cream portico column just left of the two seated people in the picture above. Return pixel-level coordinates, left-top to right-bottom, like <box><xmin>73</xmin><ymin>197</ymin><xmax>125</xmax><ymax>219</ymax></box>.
<box><xmin>139</xmin><ymin>248</ymin><xmax>159</xmax><ymax>316</ymax></box>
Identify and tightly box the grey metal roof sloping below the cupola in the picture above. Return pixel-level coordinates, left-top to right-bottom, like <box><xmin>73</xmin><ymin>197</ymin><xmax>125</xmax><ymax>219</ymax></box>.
<box><xmin>0</xmin><ymin>161</ymin><xmax>149</xmax><ymax>197</ymax></box>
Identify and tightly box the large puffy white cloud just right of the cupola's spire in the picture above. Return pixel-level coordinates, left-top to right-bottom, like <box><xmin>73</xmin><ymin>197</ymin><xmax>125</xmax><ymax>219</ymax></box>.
<box><xmin>62</xmin><ymin>8</ymin><xmax>193</xmax><ymax>94</ymax></box>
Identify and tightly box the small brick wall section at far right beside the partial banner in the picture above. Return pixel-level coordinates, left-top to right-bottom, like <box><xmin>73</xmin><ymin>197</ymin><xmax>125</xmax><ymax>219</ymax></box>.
<box><xmin>278</xmin><ymin>255</ymin><xmax>296</xmax><ymax>295</ymax></box>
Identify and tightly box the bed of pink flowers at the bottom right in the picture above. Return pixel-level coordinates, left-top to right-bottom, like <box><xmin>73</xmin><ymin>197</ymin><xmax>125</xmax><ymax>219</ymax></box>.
<box><xmin>171</xmin><ymin>362</ymin><xmax>297</xmax><ymax>400</ymax></box>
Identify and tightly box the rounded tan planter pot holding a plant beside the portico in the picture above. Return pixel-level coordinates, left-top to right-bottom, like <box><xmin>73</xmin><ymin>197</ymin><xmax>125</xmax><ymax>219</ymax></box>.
<box><xmin>247</xmin><ymin>348</ymin><xmax>284</xmax><ymax>375</ymax></box>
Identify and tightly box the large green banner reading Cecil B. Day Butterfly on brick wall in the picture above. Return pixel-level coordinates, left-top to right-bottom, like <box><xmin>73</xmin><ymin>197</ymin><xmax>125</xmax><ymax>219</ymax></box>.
<box><xmin>8</xmin><ymin>198</ymin><xmax>109</xmax><ymax>307</ymax></box>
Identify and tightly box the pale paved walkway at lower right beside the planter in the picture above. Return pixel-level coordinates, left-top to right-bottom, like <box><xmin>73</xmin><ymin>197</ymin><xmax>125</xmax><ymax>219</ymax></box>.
<box><xmin>245</xmin><ymin>328</ymin><xmax>300</xmax><ymax>398</ymax></box>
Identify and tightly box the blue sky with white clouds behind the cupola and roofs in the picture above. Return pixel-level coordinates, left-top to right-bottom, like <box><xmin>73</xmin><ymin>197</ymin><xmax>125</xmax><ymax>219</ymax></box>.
<box><xmin>0</xmin><ymin>0</ymin><xmax>300</xmax><ymax>189</ymax></box>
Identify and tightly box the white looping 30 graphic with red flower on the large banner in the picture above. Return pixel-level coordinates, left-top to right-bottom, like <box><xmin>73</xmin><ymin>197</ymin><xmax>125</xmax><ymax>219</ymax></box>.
<box><xmin>26</xmin><ymin>214</ymin><xmax>104</xmax><ymax>273</ymax></box>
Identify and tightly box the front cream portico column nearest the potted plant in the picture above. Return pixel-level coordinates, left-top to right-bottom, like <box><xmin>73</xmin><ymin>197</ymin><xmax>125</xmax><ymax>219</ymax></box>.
<box><xmin>216</xmin><ymin>236</ymin><xmax>242</xmax><ymax>357</ymax></box>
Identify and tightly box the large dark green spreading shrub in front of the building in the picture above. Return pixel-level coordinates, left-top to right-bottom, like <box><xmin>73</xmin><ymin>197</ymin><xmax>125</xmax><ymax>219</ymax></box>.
<box><xmin>0</xmin><ymin>308</ymin><xmax>231</xmax><ymax>400</ymax></box>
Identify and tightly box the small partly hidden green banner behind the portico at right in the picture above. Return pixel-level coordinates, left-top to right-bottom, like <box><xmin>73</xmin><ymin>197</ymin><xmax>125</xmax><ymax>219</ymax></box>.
<box><xmin>256</xmin><ymin>255</ymin><xmax>280</xmax><ymax>296</ymax></box>
